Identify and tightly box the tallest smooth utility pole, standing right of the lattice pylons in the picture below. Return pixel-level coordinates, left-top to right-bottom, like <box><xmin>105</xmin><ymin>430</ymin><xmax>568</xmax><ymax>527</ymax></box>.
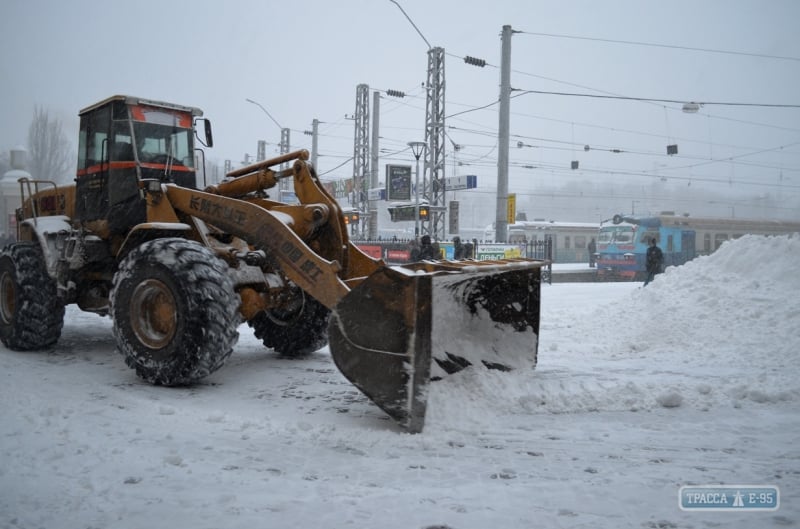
<box><xmin>495</xmin><ymin>25</ymin><xmax>513</xmax><ymax>242</ymax></box>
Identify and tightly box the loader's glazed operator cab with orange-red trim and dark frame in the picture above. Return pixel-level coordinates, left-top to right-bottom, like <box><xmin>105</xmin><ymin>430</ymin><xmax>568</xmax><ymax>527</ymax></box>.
<box><xmin>75</xmin><ymin>96</ymin><xmax>208</xmax><ymax>236</ymax></box>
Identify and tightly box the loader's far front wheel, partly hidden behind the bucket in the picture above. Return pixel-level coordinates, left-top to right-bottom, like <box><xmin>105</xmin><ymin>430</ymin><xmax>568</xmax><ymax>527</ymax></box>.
<box><xmin>247</xmin><ymin>291</ymin><xmax>331</xmax><ymax>357</ymax></box>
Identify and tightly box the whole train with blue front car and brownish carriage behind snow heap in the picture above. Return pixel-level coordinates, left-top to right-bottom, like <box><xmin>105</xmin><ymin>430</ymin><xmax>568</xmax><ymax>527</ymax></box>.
<box><xmin>597</xmin><ymin>212</ymin><xmax>800</xmax><ymax>280</ymax></box>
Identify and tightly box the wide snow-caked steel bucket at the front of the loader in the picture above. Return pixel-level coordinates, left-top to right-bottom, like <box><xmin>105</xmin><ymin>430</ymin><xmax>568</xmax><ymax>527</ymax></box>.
<box><xmin>329</xmin><ymin>260</ymin><xmax>543</xmax><ymax>433</ymax></box>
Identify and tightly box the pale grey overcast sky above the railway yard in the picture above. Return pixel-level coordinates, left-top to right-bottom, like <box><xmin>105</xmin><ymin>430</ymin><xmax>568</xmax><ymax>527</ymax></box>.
<box><xmin>0</xmin><ymin>0</ymin><xmax>800</xmax><ymax>221</ymax></box>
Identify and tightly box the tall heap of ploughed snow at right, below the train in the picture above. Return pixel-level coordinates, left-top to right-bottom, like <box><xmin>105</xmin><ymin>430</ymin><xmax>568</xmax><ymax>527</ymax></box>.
<box><xmin>619</xmin><ymin>235</ymin><xmax>800</xmax><ymax>360</ymax></box>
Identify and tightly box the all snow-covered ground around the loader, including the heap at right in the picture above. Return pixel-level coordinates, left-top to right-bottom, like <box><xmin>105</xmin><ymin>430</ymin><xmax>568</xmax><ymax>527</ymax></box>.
<box><xmin>0</xmin><ymin>235</ymin><xmax>800</xmax><ymax>529</ymax></box>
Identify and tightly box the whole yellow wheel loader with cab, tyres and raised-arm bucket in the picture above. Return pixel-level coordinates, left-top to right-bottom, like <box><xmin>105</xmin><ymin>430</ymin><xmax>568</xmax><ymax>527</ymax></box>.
<box><xmin>0</xmin><ymin>96</ymin><xmax>543</xmax><ymax>432</ymax></box>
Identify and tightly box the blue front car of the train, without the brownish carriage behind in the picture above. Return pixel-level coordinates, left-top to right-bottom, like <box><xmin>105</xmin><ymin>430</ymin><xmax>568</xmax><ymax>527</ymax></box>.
<box><xmin>597</xmin><ymin>215</ymin><xmax>696</xmax><ymax>280</ymax></box>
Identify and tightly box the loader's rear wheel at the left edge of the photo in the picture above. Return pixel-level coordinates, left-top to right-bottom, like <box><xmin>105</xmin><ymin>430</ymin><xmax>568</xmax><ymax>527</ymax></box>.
<box><xmin>0</xmin><ymin>242</ymin><xmax>64</xmax><ymax>351</ymax></box>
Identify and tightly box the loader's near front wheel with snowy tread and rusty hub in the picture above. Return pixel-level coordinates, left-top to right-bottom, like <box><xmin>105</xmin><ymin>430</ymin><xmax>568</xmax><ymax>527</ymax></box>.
<box><xmin>111</xmin><ymin>238</ymin><xmax>240</xmax><ymax>386</ymax></box>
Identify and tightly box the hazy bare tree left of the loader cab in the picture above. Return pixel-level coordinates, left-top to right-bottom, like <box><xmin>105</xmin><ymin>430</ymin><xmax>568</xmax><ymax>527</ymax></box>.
<box><xmin>28</xmin><ymin>106</ymin><xmax>74</xmax><ymax>183</ymax></box>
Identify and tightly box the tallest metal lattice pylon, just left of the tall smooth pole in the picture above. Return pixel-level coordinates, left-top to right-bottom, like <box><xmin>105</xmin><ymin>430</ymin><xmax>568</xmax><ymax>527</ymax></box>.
<box><xmin>421</xmin><ymin>48</ymin><xmax>447</xmax><ymax>241</ymax></box>
